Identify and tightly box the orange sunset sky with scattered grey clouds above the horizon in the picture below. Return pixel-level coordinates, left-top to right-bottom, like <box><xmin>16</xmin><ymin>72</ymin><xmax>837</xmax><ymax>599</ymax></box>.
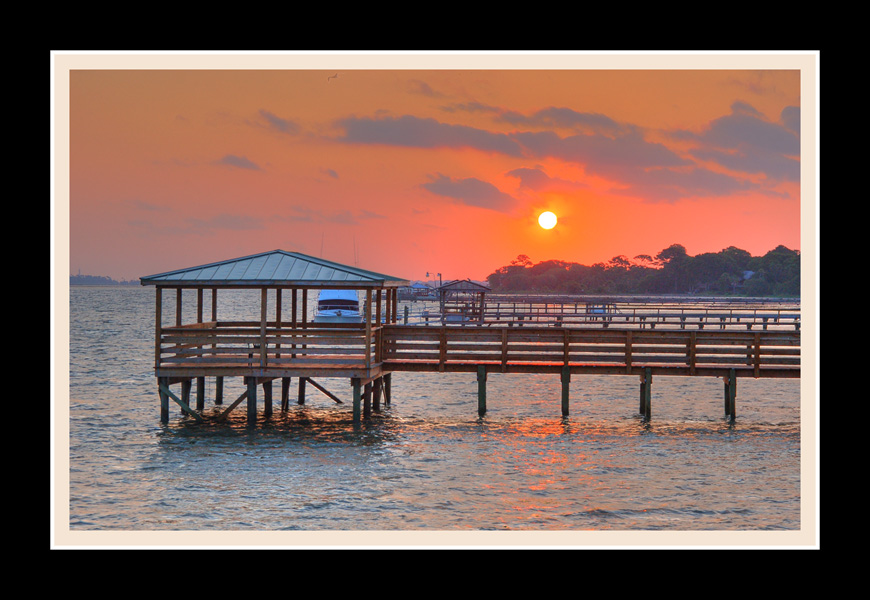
<box><xmin>57</xmin><ymin>55</ymin><xmax>807</xmax><ymax>280</ymax></box>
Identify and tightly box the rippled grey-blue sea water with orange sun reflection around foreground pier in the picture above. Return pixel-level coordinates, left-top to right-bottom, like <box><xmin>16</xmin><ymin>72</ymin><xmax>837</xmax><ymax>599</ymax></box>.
<box><xmin>60</xmin><ymin>287</ymin><xmax>801</xmax><ymax>544</ymax></box>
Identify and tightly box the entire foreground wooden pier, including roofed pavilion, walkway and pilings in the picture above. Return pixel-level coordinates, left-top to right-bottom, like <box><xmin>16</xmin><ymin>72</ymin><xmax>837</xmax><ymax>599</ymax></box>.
<box><xmin>141</xmin><ymin>251</ymin><xmax>801</xmax><ymax>424</ymax></box>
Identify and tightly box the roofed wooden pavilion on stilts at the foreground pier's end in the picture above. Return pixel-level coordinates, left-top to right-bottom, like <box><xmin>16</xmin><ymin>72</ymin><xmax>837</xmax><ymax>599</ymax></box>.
<box><xmin>140</xmin><ymin>250</ymin><xmax>409</xmax><ymax>423</ymax></box>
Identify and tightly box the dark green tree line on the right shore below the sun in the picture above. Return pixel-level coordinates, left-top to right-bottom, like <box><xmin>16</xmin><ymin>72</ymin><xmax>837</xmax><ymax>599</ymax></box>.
<box><xmin>487</xmin><ymin>244</ymin><xmax>801</xmax><ymax>297</ymax></box>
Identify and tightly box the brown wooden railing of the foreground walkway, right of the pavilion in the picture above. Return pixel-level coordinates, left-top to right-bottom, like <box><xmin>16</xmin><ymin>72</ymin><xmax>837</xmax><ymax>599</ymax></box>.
<box><xmin>382</xmin><ymin>325</ymin><xmax>800</xmax><ymax>377</ymax></box>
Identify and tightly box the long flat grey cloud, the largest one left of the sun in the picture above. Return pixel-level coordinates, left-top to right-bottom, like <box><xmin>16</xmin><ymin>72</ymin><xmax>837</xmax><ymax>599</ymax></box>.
<box><xmin>339</xmin><ymin>115</ymin><xmax>521</xmax><ymax>156</ymax></box>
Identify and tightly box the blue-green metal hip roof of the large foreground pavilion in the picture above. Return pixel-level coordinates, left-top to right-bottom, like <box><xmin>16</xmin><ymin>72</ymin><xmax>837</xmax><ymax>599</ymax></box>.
<box><xmin>139</xmin><ymin>250</ymin><xmax>409</xmax><ymax>288</ymax></box>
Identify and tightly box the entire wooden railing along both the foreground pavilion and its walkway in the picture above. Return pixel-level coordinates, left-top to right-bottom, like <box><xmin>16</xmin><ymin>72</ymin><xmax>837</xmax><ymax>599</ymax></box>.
<box><xmin>156</xmin><ymin>322</ymin><xmax>801</xmax><ymax>377</ymax></box>
